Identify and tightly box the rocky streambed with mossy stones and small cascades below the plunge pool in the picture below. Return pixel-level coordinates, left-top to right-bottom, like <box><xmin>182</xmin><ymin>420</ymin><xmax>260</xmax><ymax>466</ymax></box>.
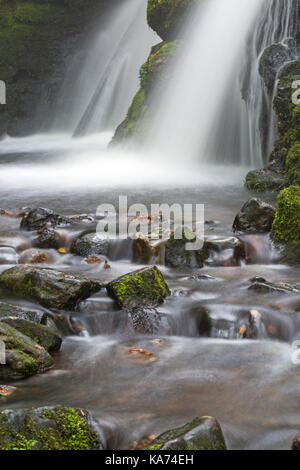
<box><xmin>0</xmin><ymin>181</ymin><xmax>300</xmax><ymax>449</ymax></box>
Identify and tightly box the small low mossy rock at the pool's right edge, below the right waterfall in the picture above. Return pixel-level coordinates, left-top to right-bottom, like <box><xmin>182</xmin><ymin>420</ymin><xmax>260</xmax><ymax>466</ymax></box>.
<box><xmin>245</xmin><ymin>168</ymin><xmax>285</xmax><ymax>192</ymax></box>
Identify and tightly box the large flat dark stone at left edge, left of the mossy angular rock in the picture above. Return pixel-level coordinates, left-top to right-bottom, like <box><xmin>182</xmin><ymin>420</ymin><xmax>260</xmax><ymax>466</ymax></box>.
<box><xmin>0</xmin><ymin>266</ymin><xmax>102</xmax><ymax>310</ymax></box>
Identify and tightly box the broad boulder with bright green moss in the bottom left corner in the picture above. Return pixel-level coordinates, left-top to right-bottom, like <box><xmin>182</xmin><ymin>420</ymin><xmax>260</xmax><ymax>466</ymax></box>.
<box><xmin>0</xmin><ymin>406</ymin><xmax>104</xmax><ymax>450</ymax></box>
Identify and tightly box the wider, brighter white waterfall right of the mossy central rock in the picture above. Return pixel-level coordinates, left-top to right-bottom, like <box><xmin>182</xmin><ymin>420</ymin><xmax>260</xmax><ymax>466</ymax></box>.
<box><xmin>147</xmin><ymin>0</ymin><xmax>294</xmax><ymax>166</ymax></box>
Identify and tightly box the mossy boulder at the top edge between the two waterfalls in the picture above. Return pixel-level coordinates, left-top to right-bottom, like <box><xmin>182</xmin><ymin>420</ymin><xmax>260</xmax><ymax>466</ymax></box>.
<box><xmin>147</xmin><ymin>0</ymin><xmax>201</xmax><ymax>41</ymax></box>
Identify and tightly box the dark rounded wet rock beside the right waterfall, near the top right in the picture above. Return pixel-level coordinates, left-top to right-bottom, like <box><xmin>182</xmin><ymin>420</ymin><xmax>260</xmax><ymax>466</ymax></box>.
<box><xmin>259</xmin><ymin>44</ymin><xmax>293</xmax><ymax>95</ymax></box>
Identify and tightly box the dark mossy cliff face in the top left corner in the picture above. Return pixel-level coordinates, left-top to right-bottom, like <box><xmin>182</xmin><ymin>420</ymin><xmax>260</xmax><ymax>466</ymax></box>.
<box><xmin>0</xmin><ymin>0</ymin><xmax>117</xmax><ymax>135</ymax></box>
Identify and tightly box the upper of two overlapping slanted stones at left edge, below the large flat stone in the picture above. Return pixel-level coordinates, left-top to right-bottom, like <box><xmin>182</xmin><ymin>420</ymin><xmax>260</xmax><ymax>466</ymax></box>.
<box><xmin>0</xmin><ymin>302</ymin><xmax>62</xmax><ymax>352</ymax></box>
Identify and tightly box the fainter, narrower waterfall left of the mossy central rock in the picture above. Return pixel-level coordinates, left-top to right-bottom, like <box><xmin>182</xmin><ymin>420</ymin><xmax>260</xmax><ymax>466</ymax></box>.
<box><xmin>53</xmin><ymin>0</ymin><xmax>159</xmax><ymax>136</ymax></box>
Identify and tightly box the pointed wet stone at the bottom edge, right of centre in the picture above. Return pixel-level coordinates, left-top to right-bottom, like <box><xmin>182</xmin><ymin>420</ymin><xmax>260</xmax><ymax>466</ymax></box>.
<box><xmin>146</xmin><ymin>416</ymin><xmax>227</xmax><ymax>450</ymax></box>
